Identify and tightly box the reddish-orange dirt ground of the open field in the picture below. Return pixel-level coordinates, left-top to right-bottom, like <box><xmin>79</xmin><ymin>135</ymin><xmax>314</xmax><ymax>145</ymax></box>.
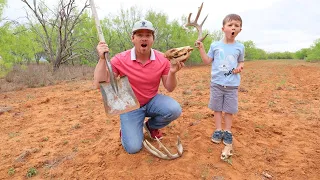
<box><xmin>0</xmin><ymin>61</ymin><xmax>320</xmax><ymax>180</ymax></box>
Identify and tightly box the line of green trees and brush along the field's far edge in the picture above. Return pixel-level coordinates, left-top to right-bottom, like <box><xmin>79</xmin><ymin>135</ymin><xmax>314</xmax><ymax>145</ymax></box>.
<box><xmin>0</xmin><ymin>0</ymin><xmax>320</xmax><ymax>76</ymax></box>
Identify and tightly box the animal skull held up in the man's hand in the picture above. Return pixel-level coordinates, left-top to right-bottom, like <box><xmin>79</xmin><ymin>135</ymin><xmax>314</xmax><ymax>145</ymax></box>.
<box><xmin>164</xmin><ymin>46</ymin><xmax>193</xmax><ymax>64</ymax></box>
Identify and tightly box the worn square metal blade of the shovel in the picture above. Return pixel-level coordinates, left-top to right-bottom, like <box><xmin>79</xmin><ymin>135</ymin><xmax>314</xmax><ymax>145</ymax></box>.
<box><xmin>100</xmin><ymin>76</ymin><xmax>140</xmax><ymax>114</ymax></box>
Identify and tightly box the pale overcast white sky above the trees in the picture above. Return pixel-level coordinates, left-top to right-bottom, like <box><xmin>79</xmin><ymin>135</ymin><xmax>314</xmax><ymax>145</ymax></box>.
<box><xmin>3</xmin><ymin>0</ymin><xmax>320</xmax><ymax>52</ymax></box>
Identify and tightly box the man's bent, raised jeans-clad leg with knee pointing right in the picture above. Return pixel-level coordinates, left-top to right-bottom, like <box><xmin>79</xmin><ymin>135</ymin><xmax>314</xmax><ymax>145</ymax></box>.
<box><xmin>146</xmin><ymin>94</ymin><xmax>182</xmax><ymax>129</ymax></box>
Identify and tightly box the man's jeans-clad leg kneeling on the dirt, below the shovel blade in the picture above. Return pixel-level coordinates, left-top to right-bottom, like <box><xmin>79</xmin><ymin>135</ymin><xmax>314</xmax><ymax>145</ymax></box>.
<box><xmin>120</xmin><ymin>107</ymin><xmax>145</xmax><ymax>154</ymax></box>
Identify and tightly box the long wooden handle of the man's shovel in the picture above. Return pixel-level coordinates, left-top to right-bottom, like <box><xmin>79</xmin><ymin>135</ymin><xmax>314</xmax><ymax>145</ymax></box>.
<box><xmin>90</xmin><ymin>0</ymin><xmax>118</xmax><ymax>93</ymax></box>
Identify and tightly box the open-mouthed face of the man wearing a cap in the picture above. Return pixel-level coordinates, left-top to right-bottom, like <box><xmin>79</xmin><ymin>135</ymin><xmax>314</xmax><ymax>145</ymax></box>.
<box><xmin>131</xmin><ymin>29</ymin><xmax>154</xmax><ymax>53</ymax></box>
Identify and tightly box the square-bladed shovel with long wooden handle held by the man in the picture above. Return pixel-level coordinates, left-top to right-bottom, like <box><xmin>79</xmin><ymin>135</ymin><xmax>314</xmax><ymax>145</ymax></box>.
<box><xmin>90</xmin><ymin>0</ymin><xmax>140</xmax><ymax>114</ymax></box>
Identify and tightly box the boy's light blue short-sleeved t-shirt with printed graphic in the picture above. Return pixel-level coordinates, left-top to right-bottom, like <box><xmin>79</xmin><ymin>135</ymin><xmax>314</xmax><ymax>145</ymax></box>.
<box><xmin>208</xmin><ymin>40</ymin><xmax>244</xmax><ymax>86</ymax></box>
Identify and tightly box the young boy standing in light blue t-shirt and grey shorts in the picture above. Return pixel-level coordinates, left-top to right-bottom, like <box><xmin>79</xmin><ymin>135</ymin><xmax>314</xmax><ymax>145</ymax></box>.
<box><xmin>196</xmin><ymin>14</ymin><xmax>244</xmax><ymax>145</ymax></box>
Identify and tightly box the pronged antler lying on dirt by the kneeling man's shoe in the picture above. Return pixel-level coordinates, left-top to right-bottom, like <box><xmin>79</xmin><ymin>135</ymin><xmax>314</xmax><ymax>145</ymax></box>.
<box><xmin>143</xmin><ymin>136</ymin><xmax>183</xmax><ymax>160</ymax></box>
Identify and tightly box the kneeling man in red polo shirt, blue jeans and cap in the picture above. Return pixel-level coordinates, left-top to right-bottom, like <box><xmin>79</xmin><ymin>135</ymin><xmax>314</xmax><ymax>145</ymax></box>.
<box><xmin>94</xmin><ymin>20</ymin><xmax>184</xmax><ymax>154</ymax></box>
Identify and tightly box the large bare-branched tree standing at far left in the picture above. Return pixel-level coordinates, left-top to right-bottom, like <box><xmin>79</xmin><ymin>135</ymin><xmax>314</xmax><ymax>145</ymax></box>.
<box><xmin>22</xmin><ymin>0</ymin><xmax>89</xmax><ymax>71</ymax></box>
